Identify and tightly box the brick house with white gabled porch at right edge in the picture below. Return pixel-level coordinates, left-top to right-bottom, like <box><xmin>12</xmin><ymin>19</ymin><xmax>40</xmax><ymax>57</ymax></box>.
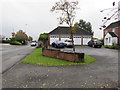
<box><xmin>103</xmin><ymin>20</ymin><xmax>120</xmax><ymax>45</ymax></box>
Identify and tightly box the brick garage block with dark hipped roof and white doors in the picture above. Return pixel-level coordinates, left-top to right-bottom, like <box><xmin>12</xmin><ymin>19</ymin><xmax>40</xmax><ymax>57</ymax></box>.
<box><xmin>48</xmin><ymin>26</ymin><xmax>93</xmax><ymax>45</ymax></box>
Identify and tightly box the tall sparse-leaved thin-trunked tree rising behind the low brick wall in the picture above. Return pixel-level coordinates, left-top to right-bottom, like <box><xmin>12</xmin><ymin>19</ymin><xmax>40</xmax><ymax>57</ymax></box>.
<box><xmin>51</xmin><ymin>0</ymin><xmax>78</xmax><ymax>52</ymax></box>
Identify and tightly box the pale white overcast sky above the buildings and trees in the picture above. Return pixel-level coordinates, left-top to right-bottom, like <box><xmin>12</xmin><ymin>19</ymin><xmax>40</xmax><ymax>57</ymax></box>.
<box><xmin>0</xmin><ymin>0</ymin><xmax>120</xmax><ymax>40</ymax></box>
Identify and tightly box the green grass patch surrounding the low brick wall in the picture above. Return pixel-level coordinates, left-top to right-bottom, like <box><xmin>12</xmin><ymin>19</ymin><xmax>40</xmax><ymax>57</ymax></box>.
<box><xmin>21</xmin><ymin>48</ymin><xmax>96</xmax><ymax>66</ymax></box>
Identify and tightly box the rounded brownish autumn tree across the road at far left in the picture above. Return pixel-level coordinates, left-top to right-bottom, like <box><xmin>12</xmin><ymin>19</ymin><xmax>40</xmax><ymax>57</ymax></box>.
<box><xmin>15</xmin><ymin>30</ymin><xmax>28</xmax><ymax>44</ymax></box>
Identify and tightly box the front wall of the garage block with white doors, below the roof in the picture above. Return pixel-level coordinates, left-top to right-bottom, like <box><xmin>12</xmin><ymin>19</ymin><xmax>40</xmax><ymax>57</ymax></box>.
<box><xmin>48</xmin><ymin>35</ymin><xmax>92</xmax><ymax>45</ymax></box>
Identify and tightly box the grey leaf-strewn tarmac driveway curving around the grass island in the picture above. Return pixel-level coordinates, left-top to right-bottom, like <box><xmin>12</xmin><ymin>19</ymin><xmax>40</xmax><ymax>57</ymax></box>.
<box><xmin>2</xmin><ymin>46</ymin><xmax>118</xmax><ymax>88</ymax></box>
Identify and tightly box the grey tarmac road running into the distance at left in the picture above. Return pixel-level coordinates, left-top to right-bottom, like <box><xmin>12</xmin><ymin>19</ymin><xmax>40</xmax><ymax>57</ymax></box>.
<box><xmin>0</xmin><ymin>44</ymin><xmax>34</xmax><ymax>73</ymax></box>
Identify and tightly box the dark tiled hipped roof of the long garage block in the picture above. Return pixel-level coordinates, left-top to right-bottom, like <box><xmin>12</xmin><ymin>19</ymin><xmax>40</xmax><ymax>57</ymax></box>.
<box><xmin>49</xmin><ymin>26</ymin><xmax>93</xmax><ymax>35</ymax></box>
